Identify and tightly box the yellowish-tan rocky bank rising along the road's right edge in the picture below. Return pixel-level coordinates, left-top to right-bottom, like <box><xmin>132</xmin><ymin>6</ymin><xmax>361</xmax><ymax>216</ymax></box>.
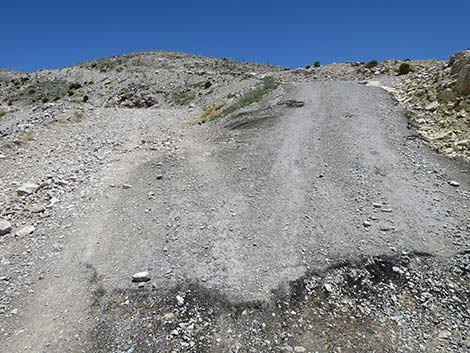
<box><xmin>394</xmin><ymin>51</ymin><xmax>470</xmax><ymax>159</ymax></box>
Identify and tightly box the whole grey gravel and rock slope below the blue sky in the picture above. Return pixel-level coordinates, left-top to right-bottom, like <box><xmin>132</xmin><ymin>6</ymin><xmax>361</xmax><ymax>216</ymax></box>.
<box><xmin>0</xmin><ymin>52</ymin><xmax>470</xmax><ymax>353</ymax></box>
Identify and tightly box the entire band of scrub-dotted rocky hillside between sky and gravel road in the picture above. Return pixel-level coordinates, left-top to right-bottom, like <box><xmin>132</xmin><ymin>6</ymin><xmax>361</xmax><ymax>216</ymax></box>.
<box><xmin>0</xmin><ymin>51</ymin><xmax>470</xmax><ymax>159</ymax></box>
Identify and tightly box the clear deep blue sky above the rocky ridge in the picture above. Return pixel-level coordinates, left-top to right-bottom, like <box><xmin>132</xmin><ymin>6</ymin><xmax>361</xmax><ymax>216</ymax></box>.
<box><xmin>0</xmin><ymin>0</ymin><xmax>470</xmax><ymax>71</ymax></box>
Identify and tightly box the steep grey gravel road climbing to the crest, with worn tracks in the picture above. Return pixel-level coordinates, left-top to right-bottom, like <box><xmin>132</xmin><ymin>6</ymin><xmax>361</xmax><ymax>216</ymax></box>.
<box><xmin>2</xmin><ymin>82</ymin><xmax>470</xmax><ymax>352</ymax></box>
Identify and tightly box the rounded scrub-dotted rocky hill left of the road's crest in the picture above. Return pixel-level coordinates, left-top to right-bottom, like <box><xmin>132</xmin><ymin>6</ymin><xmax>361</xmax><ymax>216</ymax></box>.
<box><xmin>0</xmin><ymin>52</ymin><xmax>283</xmax><ymax>136</ymax></box>
